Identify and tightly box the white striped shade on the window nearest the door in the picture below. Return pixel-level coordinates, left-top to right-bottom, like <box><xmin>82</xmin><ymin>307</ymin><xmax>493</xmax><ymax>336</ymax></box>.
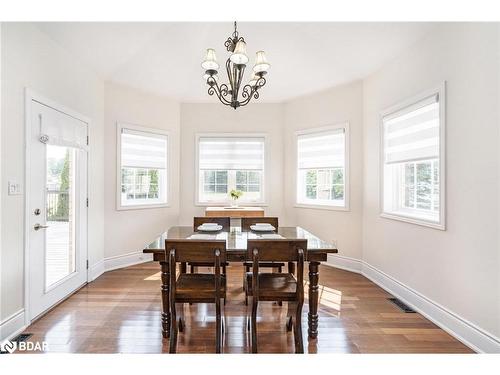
<box><xmin>121</xmin><ymin>128</ymin><xmax>168</xmax><ymax>169</ymax></box>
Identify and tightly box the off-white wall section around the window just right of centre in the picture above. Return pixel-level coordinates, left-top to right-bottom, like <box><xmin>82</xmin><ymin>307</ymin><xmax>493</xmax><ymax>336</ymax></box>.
<box><xmin>284</xmin><ymin>81</ymin><xmax>363</xmax><ymax>259</ymax></box>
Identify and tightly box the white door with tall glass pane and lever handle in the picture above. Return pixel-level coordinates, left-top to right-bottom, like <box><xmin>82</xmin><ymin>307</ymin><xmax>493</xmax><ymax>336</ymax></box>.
<box><xmin>26</xmin><ymin>99</ymin><xmax>87</xmax><ymax>320</ymax></box>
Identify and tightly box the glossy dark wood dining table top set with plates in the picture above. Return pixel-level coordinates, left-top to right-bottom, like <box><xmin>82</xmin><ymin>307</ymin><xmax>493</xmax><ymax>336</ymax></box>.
<box><xmin>143</xmin><ymin>226</ymin><xmax>338</xmax><ymax>262</ymax></box>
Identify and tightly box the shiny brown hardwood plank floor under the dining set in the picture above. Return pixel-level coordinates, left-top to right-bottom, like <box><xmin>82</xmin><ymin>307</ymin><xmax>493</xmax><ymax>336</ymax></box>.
<box><xmin>19</xmin><ymin>262</ymin><xmax>472</xmax><ymax>353</ymax></box>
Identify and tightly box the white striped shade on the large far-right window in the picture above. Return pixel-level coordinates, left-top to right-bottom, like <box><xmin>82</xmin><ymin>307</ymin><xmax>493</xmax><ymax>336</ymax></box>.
<box><xmin>382</xmin><ymin>94</ymin><xmax>439</xmax><ymax>164</ymax></box>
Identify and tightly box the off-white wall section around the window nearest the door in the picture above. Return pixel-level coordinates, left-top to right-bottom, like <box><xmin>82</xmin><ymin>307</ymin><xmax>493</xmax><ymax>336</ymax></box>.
<box><xmin>104</xmin><ymin>83</ymin><xmax>180</xmax><ymax>258</ymax></box>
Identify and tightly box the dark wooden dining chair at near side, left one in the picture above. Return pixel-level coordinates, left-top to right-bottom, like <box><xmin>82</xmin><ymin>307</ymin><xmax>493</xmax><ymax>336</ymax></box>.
<box><xmin>165</xmin><ymin>240</ymin><xmax>226</xmax><ymax>353</ymax></box>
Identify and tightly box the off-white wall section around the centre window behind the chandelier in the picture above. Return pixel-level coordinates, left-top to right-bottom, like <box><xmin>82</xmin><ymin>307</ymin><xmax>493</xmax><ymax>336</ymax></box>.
<box><xmin>180</xmin><ymin>103</ymin><xmax>283</xmax><ymax>225</ymax></box>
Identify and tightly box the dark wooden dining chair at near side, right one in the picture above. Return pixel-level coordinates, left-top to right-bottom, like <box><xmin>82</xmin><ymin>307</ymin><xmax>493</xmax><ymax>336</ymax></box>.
<box><xmin>245</xmin><ymin>239</ymin><xmax>307</xmax><ymax>353</ymax></box>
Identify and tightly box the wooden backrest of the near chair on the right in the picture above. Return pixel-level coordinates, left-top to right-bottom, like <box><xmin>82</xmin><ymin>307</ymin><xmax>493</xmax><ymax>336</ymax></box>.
<box><xmin>247</xmin><ymin>239</ymin><xmax>307</xmax><ymax>262</ymax></box>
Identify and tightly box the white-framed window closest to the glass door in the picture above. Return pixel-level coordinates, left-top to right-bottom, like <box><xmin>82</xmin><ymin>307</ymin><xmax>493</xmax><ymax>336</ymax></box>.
<box><xmin>117</xmin><ymin>125</ymin><xmax>168</xmax><ymax>209</ymax></box>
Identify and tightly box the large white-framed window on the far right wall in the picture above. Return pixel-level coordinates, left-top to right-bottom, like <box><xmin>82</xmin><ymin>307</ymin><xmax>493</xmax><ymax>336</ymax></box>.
<box><xmin>382</xmin><ymin>88</ymin><xmax>444</xmax><ymax>229</ymax></box>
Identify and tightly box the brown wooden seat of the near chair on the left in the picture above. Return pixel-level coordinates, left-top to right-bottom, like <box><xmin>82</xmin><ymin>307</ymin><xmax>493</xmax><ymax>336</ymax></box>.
<box><xmin>175</xmin><ymin>273</ymin><xmax>226</xmax><ymax>300</ymax></box>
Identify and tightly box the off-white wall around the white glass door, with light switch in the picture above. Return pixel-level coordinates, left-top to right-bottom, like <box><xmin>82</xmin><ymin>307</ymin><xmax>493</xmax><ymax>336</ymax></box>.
<box><xmin>0</xmin><ymin>23</ymin><xmax>104</xmax><ymax>320</ymax></box>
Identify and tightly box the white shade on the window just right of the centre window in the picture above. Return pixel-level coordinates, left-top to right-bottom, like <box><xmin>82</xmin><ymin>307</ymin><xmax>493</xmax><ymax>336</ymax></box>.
<box><xmin>297</xmin><ymin>129</ymin><xmax>345</xmax><ymax>169</ymax></box>
